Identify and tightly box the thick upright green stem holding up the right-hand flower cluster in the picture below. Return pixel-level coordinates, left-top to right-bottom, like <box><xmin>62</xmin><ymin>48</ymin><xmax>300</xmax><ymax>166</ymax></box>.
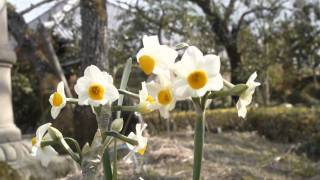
<box><xmin>193</xmin><ymin>111</ymin><xmax>205</xmax><ymax>180</ymax></box>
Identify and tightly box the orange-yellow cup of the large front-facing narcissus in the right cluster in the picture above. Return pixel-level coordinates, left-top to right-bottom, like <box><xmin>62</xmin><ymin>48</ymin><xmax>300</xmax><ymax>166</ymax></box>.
<box><xmin>187</xmin><ymin>69</ymin><xmax>208</xmax><ymax>89</ymax></box>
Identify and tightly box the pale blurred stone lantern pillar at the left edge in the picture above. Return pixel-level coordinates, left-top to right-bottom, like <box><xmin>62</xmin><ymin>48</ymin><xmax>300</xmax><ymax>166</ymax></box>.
<box><xmin>0</xmin><ymin>0</ymin><xmax>30</xmax><ymax>161</ymax></box>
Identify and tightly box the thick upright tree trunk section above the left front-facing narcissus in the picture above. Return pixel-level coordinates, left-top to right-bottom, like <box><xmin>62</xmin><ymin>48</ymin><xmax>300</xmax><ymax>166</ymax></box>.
<box><xmin>80</xmin><ymin>0</ymin><xmax>109</xmax><ymax>70</ymax></box>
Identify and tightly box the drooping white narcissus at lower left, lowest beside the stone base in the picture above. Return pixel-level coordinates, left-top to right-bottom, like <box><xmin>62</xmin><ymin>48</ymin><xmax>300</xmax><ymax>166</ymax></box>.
<box><xmin>31</xmin><ymin>123</ymin><xmax>58</xmax><ymax>167</ymax></box>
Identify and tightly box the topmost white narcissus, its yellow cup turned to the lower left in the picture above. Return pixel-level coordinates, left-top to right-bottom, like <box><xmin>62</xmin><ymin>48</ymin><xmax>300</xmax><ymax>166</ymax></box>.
<box><xmin>137</xmin><ymin>36</ymin><xmax>178</xmax><ymax>75</ymax></box>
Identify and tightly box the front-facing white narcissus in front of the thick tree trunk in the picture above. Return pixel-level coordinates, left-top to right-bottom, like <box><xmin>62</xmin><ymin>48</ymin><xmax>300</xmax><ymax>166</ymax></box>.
<box><xmin>74</xmin><ymin>65</ymin><xmax>119</xmax><ymax>106</ymax></box>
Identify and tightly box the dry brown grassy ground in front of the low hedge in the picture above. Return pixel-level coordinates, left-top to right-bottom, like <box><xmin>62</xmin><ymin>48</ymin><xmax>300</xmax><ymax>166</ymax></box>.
<box><xmin>118</xmin><ymin>132</ymin><xmax>320</xmax><ymax>180</ymax></box>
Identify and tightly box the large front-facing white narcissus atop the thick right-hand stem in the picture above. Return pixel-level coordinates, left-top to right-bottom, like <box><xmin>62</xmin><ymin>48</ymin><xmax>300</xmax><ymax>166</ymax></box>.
<box><xmin>173</xmin><ymin>46</ymin><xmax>223</xmax><ymax>99</ymax></box>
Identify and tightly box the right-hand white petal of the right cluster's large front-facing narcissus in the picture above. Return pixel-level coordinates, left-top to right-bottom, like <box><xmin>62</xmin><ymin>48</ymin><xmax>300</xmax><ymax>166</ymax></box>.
<box><xmin>202</xmin><ymin>54</ymin><xmax>221</xmax><ymax>76</ymax></box>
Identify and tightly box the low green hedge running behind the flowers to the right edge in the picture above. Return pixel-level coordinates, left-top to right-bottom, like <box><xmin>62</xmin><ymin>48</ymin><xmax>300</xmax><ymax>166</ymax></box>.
<box><xmin>144</xmin><ymin>107</ymin><xmax>320</xmax><ymax>142</ymax></box>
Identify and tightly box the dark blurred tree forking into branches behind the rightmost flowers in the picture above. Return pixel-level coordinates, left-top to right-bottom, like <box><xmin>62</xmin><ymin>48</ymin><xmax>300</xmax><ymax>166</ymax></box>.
<box><xmin>190</xmin><ymin>0</ymin><xmax>282</xmax><ymax>83</ymax></box>
